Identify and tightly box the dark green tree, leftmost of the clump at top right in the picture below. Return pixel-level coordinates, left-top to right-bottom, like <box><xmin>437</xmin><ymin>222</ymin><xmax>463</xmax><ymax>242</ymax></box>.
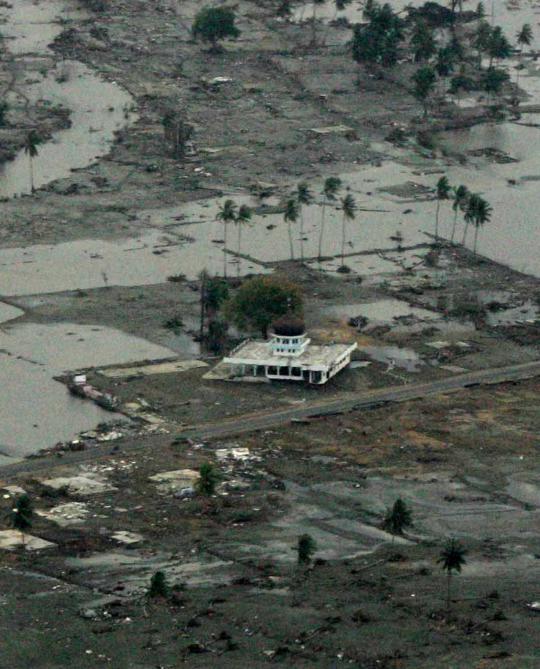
<box><xmin>351</xmin><ymin>0</ymin><xmax>404</xmax><ymax>73</ymax></box>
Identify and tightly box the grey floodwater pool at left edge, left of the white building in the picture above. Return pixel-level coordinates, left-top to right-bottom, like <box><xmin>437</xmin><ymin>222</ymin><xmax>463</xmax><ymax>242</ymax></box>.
<box><xmin>0</xmin><ymin>323</ymin><xmax>174</xmax><ymax>457</ymax></box>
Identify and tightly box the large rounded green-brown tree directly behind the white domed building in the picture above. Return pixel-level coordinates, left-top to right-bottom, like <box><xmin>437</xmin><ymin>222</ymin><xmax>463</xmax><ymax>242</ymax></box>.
<box><xmin>226</xmin><ymin>276</ymin><xmax>302</xmax><ymax>339</ymax></box>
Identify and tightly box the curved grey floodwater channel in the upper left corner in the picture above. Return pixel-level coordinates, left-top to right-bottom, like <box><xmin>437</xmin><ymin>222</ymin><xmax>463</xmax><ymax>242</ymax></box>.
<box><xmin>0</xmin><ymin>0</ymin><xmax>136</xmax><ymax>198</ymax></box>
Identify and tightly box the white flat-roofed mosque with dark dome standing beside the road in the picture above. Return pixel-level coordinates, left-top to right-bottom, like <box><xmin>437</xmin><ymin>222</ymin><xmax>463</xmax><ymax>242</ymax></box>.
<box><xmin>223</xmin><ymin>319</ymin><xmax>356</xmax><ymax>385</ymax></box>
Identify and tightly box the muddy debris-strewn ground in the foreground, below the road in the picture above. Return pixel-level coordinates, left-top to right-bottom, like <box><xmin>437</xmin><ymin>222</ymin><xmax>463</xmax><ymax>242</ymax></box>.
<box><xmin>0</xmin><ymin>381</ymin><xmax>540</xmax><ymax>669</ymax></box>
